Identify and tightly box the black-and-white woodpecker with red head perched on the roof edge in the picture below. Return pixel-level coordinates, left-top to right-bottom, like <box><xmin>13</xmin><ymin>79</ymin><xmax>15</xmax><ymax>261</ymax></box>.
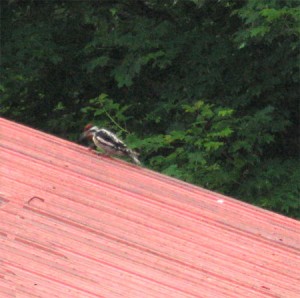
<box><xmin>80</xmin><ymin>124</ymin><xmax>141</xmax><ymax>165</ymax></box>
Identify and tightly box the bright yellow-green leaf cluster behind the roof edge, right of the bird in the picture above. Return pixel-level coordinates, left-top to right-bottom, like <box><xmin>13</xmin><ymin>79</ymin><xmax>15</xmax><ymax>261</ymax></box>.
<box><xmin>132</xmin><ymin>101</ymin><xmax>233</xmax><ymax>184</ymax></box>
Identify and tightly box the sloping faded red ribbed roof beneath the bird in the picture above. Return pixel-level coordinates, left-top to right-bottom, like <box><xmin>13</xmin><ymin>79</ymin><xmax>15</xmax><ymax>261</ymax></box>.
<box><xmin>0</xmin><ymin>118</ymin><xmax>300</xmax><ymax>298</ymax></box>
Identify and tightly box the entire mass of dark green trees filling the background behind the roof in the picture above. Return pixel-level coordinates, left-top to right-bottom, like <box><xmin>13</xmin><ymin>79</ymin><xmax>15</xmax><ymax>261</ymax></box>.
<box><xmin>0</xmin><ymin>0</ymin><xmax>300</xmax><ymax>217</ymax></box>
